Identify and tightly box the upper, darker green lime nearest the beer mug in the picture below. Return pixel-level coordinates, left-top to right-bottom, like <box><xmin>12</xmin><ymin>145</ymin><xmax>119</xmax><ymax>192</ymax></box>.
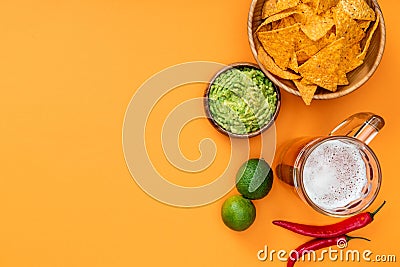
<box><xmin>236</xmin><ymin>159</ymin><xmax>274</xmax><ymax>199</ymax></box>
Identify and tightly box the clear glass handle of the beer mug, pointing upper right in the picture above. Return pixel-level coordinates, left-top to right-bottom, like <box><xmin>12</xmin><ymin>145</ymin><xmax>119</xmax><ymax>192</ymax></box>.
<box><xmin>329</xmin><ymin>112</ymin><xmax>385</xmax><ymax>145</ymax></box>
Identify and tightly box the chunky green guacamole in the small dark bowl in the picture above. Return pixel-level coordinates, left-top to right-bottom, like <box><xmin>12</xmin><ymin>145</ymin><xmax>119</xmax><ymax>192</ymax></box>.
<box><xmin>208</xmin><ymin>66</ymin><xmax>278</xmax><ymax>135</ymax></box>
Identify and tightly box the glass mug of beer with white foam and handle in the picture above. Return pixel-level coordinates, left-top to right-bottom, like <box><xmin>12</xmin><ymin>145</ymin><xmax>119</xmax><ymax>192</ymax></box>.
<box><xmin>276</xmin><ymin>112</ymin><xmax>385</xmax><ymax>217</ymax></box>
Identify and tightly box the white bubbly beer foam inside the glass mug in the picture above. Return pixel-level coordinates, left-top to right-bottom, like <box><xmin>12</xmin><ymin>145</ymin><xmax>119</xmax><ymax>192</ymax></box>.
<box><xmin>303</xmin><ymin>140</ymin><xmax>368</xmax><ymax>210</ymax></box>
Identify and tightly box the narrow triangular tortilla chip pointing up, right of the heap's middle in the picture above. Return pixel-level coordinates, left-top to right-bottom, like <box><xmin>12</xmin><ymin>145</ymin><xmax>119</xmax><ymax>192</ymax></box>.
<box><xmin>333</xmin><ymin>7</ymin><xmax>365</xmax><ymax>45</ymax></box>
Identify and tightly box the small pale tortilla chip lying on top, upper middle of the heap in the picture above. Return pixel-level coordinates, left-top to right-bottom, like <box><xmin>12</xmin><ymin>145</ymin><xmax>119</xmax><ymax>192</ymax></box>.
<box><xmin>300</xmin><ymin>12</ymin><xmax>334</xmax><ymax>41</ymax></box>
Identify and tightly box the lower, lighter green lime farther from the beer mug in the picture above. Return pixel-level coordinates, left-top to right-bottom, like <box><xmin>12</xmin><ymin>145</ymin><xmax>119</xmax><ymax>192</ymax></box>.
<box><xmin>221</xmin><ymin>195</ymin><xmax>256</xmax><ymax>231</ymax></box>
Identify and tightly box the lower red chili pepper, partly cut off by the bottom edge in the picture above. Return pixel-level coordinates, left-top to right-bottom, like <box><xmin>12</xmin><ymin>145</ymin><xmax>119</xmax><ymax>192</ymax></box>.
<box><xmin>286</xmin><ymin>235</ymin><xmax>370</xmax><ymax>267</ymax></box>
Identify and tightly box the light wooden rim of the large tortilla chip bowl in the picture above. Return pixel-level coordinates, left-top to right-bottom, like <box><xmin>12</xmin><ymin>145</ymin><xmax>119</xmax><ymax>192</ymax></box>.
<box><xmin>247</xmin><ymin>0</ymin><xmax>386</xmax><ymax>100</ymax></box>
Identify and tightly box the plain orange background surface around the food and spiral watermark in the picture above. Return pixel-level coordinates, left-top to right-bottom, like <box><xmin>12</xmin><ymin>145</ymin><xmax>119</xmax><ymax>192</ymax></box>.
<box><xmin>0</xmin><ymin>0</ymin><xmax>400</xmax><ymax>267</ymax></box>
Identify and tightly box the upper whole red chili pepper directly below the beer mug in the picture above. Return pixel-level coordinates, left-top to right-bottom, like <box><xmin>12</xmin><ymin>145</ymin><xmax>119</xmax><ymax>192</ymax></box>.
<box><xmin>272</xmin><ymin>201</ymin><xmax>386</xmax><ymax>238</ymax></box>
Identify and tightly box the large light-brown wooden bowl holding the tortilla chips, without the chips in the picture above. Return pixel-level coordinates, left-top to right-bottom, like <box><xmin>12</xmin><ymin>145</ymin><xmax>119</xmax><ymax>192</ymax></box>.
<box><xmin>247</xmin><ymin>0</ymin><xmax>386</xmax><ymax>99</ymax></box>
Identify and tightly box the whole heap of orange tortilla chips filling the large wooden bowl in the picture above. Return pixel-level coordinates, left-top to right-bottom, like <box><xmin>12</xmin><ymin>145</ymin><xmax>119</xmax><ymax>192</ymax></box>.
<box><xmin>256</xmin><ymin>0</ymin><xmax>379</xmax><ymax>100</ymax></box>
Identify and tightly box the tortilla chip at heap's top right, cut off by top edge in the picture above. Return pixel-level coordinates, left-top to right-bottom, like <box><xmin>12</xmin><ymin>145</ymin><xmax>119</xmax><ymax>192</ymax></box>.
<box><xmin>338</xmin><ymin>0</ymin><xmax>375</xmax><ymax>20</ymax></box>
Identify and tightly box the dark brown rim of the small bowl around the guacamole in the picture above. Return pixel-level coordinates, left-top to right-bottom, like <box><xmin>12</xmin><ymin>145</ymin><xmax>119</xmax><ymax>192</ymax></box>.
<box><xmin>203</xmin><ymin>62</ymin><xmax>281</xmax><ymax>138</ymax></box>
